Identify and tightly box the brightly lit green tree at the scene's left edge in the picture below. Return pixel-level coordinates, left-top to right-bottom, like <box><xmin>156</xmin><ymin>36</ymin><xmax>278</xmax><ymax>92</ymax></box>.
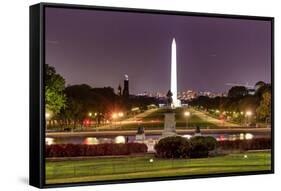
<box><xmin>45</xmin><ymin>64</ymin><xmax>66</xmax><ymax>115</ymax></box>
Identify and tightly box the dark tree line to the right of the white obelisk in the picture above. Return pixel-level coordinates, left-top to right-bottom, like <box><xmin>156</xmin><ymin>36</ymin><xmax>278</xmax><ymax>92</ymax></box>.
<box><xmin>189</xmin><ymin>82</ymin><xmax>271</xmax><ymax>122</ymax></box>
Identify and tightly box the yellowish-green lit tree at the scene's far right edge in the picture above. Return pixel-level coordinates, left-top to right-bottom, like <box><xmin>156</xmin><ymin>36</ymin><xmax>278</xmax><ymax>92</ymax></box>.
<box><xmin>256</xmin><ymin>91</ymin><xmax>271</xmax><ymax>120</ymax></box>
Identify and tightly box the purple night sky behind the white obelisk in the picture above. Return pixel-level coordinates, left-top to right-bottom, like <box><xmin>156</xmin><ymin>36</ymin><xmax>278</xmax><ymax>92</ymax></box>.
<box><xmin>46</xmin><ymin>8</ymin><xmax>271</xmax><ymax>94</ymax></box>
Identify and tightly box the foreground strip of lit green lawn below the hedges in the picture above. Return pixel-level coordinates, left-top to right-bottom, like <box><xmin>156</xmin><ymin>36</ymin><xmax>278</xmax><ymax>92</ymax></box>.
<box><xmin>46</xmin><ymin>152</ymin><xmax>271</xmax><ymax>184</ymax></box>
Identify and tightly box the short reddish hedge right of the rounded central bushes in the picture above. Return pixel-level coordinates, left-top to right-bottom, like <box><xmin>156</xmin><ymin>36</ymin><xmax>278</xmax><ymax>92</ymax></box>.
<box><xmin>215</xmin><ymin>138</ymin><xmax>271</xmax><ymax>151</ymax></box>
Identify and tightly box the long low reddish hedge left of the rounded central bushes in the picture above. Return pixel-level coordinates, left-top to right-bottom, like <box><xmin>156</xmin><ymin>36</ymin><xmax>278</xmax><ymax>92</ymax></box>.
<box><xmin>46</xmin><ymin>143</ymin><xmax>147</xmax><ymax>157</ymax></box>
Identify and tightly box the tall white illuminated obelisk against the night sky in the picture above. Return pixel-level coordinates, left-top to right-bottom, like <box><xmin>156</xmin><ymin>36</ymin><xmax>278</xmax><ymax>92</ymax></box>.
<box><xmin>171</xmin><ymin>38</ymin><xmax>181</xmax><ymax>107</ymax></box>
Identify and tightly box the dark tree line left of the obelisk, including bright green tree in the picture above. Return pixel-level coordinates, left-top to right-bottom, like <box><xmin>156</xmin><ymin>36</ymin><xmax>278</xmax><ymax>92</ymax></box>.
<box><xmin>45</xmin><ymin>65</ymin><xmax>157</xmax><ymax>128</ymax></box>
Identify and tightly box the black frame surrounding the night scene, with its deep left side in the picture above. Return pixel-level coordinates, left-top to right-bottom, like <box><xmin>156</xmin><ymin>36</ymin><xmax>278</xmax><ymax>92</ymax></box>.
<box><xmin>29</xmin><ymin>3</ymin><xmax>274</xmax><ymax>188</ymax></box>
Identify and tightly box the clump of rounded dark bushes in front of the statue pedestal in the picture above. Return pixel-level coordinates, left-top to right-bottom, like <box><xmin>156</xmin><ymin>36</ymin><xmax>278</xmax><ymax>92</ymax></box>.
<box><xmin>154</xmin><ymin>136</ymin><xmax>217</xmax><ymax>158</ymax></box>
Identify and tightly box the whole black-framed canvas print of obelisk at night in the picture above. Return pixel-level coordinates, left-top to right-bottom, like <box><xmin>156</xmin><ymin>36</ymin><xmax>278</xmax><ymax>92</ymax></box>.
<box><xmin>30</xmin><ymin>3</ymin><xmax>274</xmax><ymax>188</ymax></box>
